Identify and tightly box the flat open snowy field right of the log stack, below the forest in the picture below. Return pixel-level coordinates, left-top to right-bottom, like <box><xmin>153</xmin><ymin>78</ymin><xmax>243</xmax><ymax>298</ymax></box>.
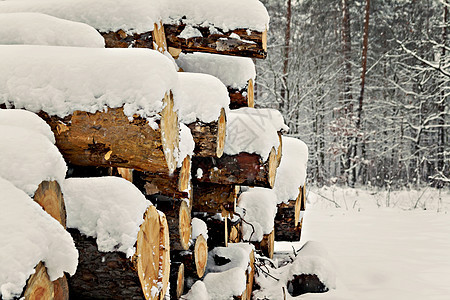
<box><xmin>276</xmin><ymin>187</ymin><xmax>450</xmax><ymax>300</ymax></box>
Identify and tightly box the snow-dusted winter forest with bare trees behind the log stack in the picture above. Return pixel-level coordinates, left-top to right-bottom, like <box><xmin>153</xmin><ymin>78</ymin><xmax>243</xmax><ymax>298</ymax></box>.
<box><xmin>255</xmin><ymin>0</ymin><xmax>450</xmax><ymax>189</ymax></box>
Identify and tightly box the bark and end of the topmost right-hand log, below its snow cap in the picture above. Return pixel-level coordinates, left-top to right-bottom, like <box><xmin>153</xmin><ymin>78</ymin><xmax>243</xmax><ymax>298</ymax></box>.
<box><xmin>164</xmin><ymin>23</ymin><xmax>267</xmax><ymax>58</ymax></box>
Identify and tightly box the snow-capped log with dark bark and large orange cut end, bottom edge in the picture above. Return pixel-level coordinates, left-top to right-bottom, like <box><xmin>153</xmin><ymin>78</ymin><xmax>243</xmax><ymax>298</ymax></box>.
<box><xmin>64</xmin><ymin>177</ymin><xmax>170</xmax><ymax>299</ymax></box>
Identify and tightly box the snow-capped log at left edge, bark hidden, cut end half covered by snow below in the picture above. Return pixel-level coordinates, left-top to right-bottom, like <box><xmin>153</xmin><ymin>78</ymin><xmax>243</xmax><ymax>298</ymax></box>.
<box><xmin>0</xmin><ymin>116</ymin><xmax>67</xmax><ymax>227</ymax></box>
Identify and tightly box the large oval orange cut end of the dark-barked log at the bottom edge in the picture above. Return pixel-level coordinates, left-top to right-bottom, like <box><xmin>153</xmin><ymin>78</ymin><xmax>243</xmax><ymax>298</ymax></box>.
<box><xmin>133</xmin><ymin>206</ymin><xmax>170</xmax><ymax>299</ymax></box>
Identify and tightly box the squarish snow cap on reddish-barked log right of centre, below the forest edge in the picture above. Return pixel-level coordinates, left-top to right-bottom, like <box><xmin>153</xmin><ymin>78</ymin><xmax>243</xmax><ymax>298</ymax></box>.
<box><xmin>224</xmin><ymin>108</ymin><xmax>280</xmax><ymax>161</ymax></box>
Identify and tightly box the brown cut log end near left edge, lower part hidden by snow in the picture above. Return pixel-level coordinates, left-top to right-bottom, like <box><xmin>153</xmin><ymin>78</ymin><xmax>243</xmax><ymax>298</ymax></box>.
<box><xmin>33</xmin><ymin>181</ymin><xmax>66</xmax><ymax>228</ymax></box>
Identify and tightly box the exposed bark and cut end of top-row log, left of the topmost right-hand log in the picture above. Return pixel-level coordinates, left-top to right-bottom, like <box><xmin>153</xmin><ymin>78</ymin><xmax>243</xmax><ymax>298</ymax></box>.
<box><xmin>100</xmin><ymin>24</ymin><xmax>167</xmax><ymax>52</ymax></box>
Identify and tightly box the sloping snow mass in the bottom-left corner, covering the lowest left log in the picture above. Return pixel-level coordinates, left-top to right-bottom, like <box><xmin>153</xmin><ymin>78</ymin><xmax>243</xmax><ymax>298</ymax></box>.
<box><xmin>0</xmin><ymin>178</ymin><xmax>78</xmax><ymax>300</ymax></box>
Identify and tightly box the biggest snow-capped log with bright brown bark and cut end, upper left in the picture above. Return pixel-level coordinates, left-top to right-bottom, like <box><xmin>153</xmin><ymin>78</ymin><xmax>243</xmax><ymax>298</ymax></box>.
<box><xmin>0</xmin><ymin>46</ymin><xmax>184</xmax><ymax>173</ymax></box>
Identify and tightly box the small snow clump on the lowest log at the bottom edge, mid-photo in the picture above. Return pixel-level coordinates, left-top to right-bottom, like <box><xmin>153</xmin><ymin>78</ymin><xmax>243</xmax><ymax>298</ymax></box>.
<box><xmin>203</xmin><ymin>268</ymin><xmax>246</xmax><ymax>300</ymax></box>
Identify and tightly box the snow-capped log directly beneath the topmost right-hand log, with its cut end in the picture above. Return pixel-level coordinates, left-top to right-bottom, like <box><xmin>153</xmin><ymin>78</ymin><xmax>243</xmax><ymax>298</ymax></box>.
<box><xmin>176</xmin><ymin>53</ymin><xmax>256</xmax><ymax>109</ymax></box>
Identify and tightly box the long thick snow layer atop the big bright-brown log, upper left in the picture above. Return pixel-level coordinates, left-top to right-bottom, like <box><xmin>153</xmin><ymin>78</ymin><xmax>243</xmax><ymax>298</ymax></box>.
<box><xmin>0</xmin><ymin>45</ymin><xmax>177</xmax><ymax>119</ymax></box>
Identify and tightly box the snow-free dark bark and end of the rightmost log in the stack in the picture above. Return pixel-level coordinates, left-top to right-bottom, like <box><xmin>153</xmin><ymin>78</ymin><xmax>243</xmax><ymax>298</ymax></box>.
<box><xmin>275</xmin><ymin>187</ymin><xmax>305</xmax><ymax>242</ymax></box>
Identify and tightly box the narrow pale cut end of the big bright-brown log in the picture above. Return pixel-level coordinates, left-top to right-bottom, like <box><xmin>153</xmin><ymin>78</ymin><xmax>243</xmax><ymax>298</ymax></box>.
<box><xmin>161</xmin><ymin>93</ymin><xmax>179</xmax><ymax>173</ymax></box>
